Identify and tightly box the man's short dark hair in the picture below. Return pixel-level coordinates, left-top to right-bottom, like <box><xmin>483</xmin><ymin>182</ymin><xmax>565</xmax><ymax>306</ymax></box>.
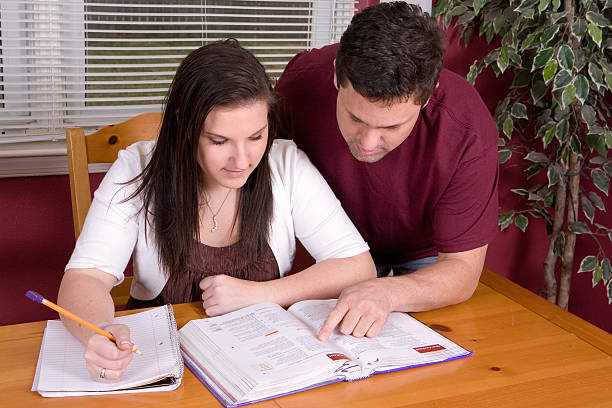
<box><xmin>336</xmin><ymin>1</ymin><xmax>444</xmax><ymax>105</ymax></box>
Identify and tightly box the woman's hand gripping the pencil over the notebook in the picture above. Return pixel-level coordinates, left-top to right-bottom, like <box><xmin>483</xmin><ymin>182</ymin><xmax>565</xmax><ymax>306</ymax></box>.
<box><xmin>84</xmin><ymin>324</ymin><xmax>134</xmax><ymax>383</ymax></box>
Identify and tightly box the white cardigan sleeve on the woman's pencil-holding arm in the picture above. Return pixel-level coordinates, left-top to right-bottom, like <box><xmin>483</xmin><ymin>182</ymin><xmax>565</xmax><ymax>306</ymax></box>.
<box><xmin>65</xmin><ymin>146</ymin><xmax>151</xmax><ymax>284</ymax></box>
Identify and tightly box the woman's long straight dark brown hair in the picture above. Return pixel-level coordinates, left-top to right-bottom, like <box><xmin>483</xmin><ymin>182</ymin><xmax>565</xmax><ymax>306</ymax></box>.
<box><xmin>128</xmin><ymin>39</ymin><xmax>277</xmax><ymax>276</ymax></box>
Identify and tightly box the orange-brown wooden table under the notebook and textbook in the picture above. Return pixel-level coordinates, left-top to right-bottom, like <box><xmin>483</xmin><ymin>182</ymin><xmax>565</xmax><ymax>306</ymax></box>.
<box><xmin>0</xmin><ymin>270</ymin><xmax>612</xmax><ymax>408</ymax></box>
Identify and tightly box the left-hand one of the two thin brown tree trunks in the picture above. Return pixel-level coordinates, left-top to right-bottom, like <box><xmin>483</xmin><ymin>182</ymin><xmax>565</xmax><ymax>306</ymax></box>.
<box><xmin>544</xmin><ymin>163</ymin><xmax>567</xmax><ymax>304</ymax></box>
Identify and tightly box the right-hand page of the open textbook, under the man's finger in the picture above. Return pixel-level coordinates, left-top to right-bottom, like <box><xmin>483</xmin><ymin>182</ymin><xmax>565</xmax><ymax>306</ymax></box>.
<box><xmin>288</xmin><ymin>299</ymin><xmax>471</xmax><ymax>377</ymax></box>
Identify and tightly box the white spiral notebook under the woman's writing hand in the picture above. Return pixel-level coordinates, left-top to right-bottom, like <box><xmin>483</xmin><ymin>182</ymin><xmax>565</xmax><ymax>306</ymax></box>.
<box><xmin>32</xmin><ymin>306</ymin><xmax>183</xmax><ymax>397</ymax></box>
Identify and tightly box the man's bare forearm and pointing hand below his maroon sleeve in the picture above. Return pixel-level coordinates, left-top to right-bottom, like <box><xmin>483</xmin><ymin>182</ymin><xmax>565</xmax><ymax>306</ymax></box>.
<box><xmin>319</xmin><ymin>245</ymin><xmax>487</xmax><ymax>341</ymax></box>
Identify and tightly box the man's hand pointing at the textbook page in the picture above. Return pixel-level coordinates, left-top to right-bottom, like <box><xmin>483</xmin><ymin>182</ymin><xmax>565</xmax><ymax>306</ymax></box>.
<box><xmin>319</xmin><ymin>278</ymin><xmax>393</xmax><ymax>341</ymax></box>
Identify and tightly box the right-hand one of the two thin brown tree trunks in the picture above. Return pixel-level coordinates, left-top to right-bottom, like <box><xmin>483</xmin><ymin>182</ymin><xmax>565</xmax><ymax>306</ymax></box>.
<box><xmin>557</xmin><ymin>150</ymin><xmax>580</xmax><ymax>310</ymax></box>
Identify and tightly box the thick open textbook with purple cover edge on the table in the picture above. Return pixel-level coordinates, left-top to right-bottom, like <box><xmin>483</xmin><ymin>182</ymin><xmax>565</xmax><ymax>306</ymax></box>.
<box><xmin>179</xmin><ymin>300</ymin><xmax>472</xmax><ymax>407</ymax></box>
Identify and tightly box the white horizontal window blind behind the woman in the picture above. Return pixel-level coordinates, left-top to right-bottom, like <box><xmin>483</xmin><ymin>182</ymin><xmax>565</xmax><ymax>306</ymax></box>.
<box><xmin>0</xmin><ymin>0</ymin><xmax>356</xmax><ymax>144</ymax></box>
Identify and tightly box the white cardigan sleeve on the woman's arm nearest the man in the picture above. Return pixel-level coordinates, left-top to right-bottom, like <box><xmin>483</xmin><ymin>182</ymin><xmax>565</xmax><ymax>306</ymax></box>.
<box><xmin>276</xmin><ymin>140</ymin><xmax>369</xmax><ymax>262</ymax></box>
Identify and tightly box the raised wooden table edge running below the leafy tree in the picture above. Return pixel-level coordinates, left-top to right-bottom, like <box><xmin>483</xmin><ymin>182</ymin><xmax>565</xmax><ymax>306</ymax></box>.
<box><xmin>480</xmin><ymin>268</ymin><xmax>612</xmax><ymax>356</ymax></box>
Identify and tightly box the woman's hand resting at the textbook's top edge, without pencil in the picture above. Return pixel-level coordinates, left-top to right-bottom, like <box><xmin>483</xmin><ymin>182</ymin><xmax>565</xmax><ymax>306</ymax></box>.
<box><xmin>200</xmin><ymin>275</ymin><xmax>273</xmax><ymax>316</ymax></box>
